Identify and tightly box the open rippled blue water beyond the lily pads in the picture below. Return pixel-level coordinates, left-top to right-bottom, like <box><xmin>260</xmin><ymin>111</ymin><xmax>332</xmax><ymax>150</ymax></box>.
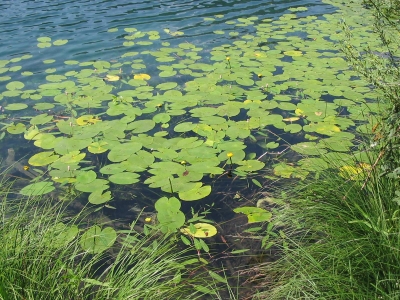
<box><xmin>0</xmin><ymin>0</ymin><xmax>334</xmax><ymax>62</ymax></box>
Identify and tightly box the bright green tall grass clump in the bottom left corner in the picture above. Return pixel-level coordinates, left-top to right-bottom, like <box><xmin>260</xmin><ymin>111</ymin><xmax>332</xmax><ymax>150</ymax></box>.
<box><xmin>0</xmin><ymin>171</ymin><xmax>225</xmax><ymax>300</ymax></box>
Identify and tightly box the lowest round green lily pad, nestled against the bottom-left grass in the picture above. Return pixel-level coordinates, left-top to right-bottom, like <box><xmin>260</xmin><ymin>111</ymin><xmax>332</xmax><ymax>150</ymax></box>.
<box><xmin>79</xmin><ymin>225</ymin><xmax>117</xmax><ymax>254</ymax></box>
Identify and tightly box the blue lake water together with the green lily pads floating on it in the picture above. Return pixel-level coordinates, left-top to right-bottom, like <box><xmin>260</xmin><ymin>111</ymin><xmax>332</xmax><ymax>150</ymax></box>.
<box><xmin>0</xmin><ymin>0</ymin><xmax>376</xmax><ymax>239</ymax></box>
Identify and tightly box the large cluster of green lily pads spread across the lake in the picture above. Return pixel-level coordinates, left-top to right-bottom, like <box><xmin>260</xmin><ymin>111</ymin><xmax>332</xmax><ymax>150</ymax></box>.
<box><xmin>0</xmin><ymin>0</ymin><xmax>384</xmax><ymax>251</ymax></box>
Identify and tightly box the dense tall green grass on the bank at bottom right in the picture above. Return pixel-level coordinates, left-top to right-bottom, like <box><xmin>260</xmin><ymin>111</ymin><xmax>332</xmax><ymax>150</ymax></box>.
<box><xmin>258</xmin><ymin>154</ymin><xmax>400</xmax><ymax>300</ymax></box>
